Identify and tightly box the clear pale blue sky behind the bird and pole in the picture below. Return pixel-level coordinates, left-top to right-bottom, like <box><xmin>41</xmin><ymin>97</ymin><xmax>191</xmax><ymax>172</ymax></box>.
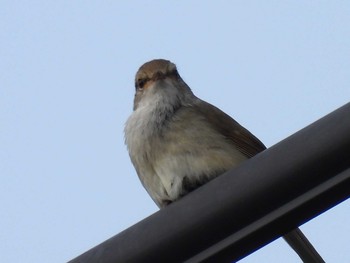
<box><xmin>0</xmin><ymin>0</ymin><xmax>350</xmax><ymax>263</ymax></box>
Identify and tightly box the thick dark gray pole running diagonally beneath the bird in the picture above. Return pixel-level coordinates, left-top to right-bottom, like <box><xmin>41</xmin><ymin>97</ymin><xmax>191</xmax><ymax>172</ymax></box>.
<box><xmin>70</xmin><ymin>103</ymin><xmax>350</xmax><ymax>263</ymax></box>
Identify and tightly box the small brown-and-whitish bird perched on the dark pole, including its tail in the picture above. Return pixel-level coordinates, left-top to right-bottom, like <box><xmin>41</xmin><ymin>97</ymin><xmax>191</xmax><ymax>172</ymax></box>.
<box><xmin>124</xmin><ymin>59</ymin><xmax>324</xmax><ymax>263</ymax></box>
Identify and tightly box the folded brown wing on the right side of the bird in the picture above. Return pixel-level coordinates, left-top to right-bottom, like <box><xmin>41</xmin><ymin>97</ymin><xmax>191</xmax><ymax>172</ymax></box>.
<box><xmin>194</xmin><ymin>101</ymin><xmax>266</xmax><ymax>158</ymax></box>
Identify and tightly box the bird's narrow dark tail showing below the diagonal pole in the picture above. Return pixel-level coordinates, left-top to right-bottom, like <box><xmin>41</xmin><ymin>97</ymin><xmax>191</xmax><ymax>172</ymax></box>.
<box><xmin>283</xmin><ymin>228</ymin><xmax>325</xmax><ymax>263</ymax></box>
